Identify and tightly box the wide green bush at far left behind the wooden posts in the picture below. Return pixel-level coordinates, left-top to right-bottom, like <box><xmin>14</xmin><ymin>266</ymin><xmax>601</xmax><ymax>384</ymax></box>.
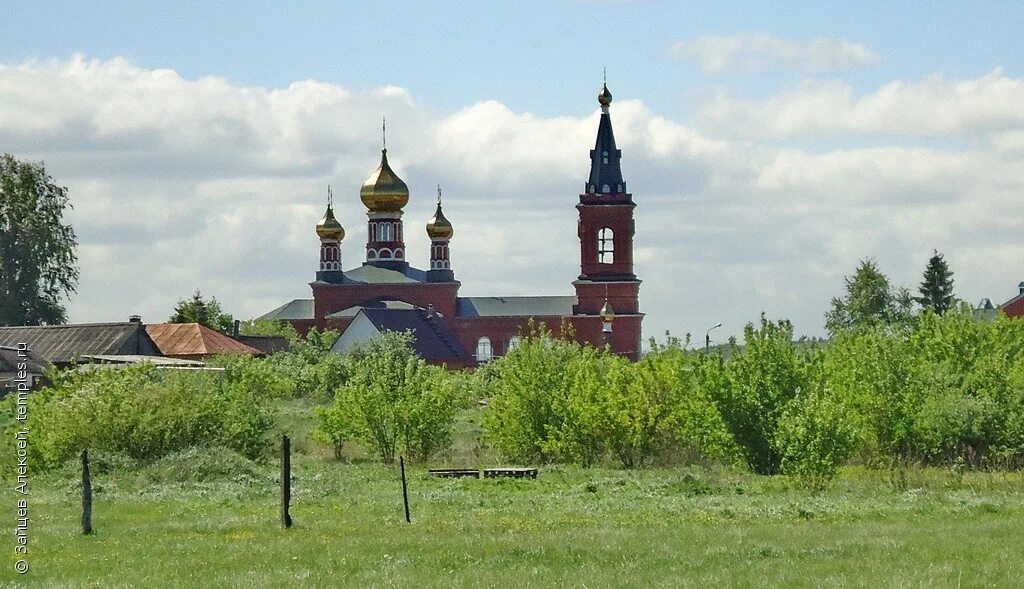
<box><xmin>19</xmin><ymin>365</ymin><xmax>275</xmax><ymax>467</ymax></box>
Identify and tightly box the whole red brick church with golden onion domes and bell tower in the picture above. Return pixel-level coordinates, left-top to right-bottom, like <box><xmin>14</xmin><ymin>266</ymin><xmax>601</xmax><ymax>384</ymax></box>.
<box><xmin>260</xmin><ymin>85</ymin><xmax>643</xmax><ymax>367</ymax></box>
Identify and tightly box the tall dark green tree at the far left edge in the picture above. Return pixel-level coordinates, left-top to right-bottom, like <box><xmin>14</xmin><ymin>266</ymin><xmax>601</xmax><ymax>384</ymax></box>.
<box><xmin>0</xmin><ymin>154</ymin><xmax>79</xmax><ymax>326</ymax></box>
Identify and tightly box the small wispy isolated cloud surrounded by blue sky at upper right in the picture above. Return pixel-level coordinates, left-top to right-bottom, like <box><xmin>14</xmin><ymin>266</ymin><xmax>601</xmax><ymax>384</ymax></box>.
<box><xmin>672</xmin><ymin>33</ymin><xmax>882</xmax><ymax>74</ymax></box>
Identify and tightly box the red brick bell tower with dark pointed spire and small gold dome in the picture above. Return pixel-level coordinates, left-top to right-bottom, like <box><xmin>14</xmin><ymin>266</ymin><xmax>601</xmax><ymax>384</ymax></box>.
<box><xmin>572</xmin><ymin>79</ymin><xmax>643</xmax><ymax>357</ymax></box>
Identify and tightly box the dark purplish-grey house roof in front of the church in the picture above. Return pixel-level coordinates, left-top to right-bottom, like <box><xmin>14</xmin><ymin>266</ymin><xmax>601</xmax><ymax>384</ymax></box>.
<box><xmin>360</xmin><ymin>308</ymin><xmax>472</xmax><ymax>362</ymax></box>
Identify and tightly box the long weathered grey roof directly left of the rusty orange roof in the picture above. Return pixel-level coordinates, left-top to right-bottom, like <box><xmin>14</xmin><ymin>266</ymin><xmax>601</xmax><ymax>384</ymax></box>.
<box><xmin>0</xmin><ymin>322</ymin><xmax>160</xmax><ymax>364</ymax></box>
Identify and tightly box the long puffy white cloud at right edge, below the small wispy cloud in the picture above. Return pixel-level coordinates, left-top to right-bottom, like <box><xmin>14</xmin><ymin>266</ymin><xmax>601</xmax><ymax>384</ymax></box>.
<box><xmin>701</xmin><ymin>69</ymin><xmax>1024</xmax><ymax>137</ymax></box>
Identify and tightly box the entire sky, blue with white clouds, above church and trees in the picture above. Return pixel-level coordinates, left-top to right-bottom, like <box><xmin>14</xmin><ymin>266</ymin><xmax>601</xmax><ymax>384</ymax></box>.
<box><xmin>0</xmin><ymin>0</ymin><xmax>1024</xmax><ymax>341</ymax></box>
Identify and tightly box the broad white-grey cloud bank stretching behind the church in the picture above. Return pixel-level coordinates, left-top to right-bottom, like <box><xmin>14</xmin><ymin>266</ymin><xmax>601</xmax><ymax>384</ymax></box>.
<box><xmin>0</xmin><ymin>57</ymin><xmax>1024</xmax><ymax>344</ymax></box>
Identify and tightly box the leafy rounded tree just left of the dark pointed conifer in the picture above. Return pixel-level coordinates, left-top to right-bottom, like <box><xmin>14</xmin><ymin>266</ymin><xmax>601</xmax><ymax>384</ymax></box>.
<box><xmin>825</xmin><ymin>259</ymin><xmax>913</xmax><ymax>335</ymax></box>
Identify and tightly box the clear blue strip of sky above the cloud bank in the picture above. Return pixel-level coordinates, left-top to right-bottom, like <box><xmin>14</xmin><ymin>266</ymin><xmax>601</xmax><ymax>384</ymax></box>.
<box><xmin>9</xmin><ymin>1</ymin><xmax>1024</xmax><ymax>118</ymax></box>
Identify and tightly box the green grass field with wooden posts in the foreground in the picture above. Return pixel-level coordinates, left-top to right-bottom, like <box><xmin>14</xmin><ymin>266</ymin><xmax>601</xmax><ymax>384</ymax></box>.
<box><xmin>8</xmin><ymin>410</ymin><xmax>1024</xmax><ymax>588</ymax></box>
